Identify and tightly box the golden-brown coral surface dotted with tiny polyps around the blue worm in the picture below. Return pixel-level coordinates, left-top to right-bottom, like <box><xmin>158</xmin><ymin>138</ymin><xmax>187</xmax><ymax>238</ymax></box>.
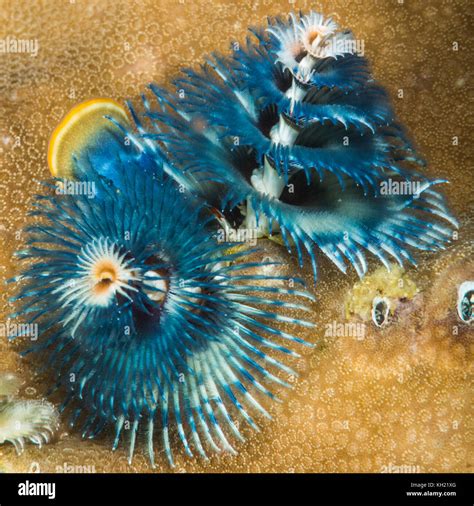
<box><xmin>0</xmin><ymin>0</ymin><xmax>474</xmax><ymax>472</ymax></box>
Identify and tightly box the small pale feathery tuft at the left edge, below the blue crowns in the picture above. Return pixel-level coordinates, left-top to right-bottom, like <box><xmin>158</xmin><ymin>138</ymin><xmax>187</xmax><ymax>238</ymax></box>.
<box><xmin>0</xmin><ymin>400</ymin><xmax>59</xmax><ymax>454</ymax></box>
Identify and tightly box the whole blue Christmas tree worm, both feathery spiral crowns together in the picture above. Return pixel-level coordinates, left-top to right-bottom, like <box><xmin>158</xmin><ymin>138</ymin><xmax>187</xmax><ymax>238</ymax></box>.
<box><xmin>10</xmin><ymin>13</ymin><xmax>456</xmax><ymax>464</ymax></box>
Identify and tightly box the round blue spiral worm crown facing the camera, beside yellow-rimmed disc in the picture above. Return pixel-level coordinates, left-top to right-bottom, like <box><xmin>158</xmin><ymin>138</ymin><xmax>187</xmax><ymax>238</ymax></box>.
<box><xmin>11</xmin><ymin>145</ymin><xmax>312</xmax><ymax>463</ymax></box>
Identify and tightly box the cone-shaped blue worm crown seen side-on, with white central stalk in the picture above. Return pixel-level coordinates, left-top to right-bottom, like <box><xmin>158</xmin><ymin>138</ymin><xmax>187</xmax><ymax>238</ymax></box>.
<box><xmin>138</xmin><ymin>13</ymin><xmax>457</xmax><ymax>278</ymax></box>
